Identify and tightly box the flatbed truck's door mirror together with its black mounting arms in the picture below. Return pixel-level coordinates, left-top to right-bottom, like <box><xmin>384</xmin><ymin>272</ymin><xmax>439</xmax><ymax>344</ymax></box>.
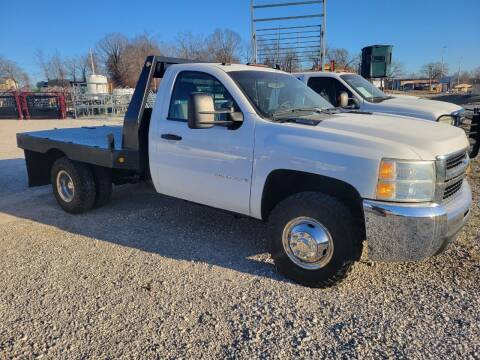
<box><xmin>188</xmin><ymin>93</ymin><xmax>243</xmax><ymax>129</ymax></box>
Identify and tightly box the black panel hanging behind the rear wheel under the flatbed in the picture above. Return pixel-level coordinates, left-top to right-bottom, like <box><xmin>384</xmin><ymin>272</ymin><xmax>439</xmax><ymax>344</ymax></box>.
<box><xmin>25</xmin><ymin>149</ymin><xmax>65</xmax><ymax>186</ymax></box>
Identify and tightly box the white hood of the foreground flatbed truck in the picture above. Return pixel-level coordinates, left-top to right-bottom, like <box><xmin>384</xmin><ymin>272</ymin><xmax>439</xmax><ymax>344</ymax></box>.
<box><xmin>317</xmin><ymin>113</ymin><xmax>469</xmax><ymax>160</ymax></box>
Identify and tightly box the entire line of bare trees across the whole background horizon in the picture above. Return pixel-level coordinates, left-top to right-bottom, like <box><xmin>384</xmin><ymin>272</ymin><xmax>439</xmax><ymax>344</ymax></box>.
<box><xmin>0</xmin><ymin>29</ymin><xmax>480</xmax><ymax>88</ymax></box>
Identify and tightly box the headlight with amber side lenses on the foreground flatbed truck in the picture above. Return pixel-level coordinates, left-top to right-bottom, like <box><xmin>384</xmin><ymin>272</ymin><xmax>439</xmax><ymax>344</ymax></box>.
<box><xmin>377</xmin><ymin>159</ymin><xmax>435</xmax><ymax>202</ymax></box>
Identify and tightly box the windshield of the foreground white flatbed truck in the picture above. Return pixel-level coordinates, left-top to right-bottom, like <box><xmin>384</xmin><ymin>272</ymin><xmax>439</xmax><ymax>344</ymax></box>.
<box><xmin>228</xmin><ymin>70</ymin><xmax>333</xmax><ymax>118</ymax></box>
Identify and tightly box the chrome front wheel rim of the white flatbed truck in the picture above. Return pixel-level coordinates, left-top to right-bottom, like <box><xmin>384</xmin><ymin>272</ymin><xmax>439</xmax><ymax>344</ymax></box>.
<box><xmin>282</xmin><ymin>217</ymin><xmax>333</xmax><ymax>270</ymax></box>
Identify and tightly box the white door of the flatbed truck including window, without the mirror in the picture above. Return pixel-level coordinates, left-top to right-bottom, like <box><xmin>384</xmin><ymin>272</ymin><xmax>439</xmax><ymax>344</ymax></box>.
<box><xmin>150</xmin><ymin>71</ymin><xmax>254</xmax><ymax>214</ymax></box>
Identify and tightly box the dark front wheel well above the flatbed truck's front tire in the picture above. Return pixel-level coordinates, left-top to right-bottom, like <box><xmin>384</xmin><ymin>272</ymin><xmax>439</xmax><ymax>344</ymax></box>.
<box><xmin>262</xmin><ymin>170</ymin><xmax>363</xmax><ymax>221</ymax></box>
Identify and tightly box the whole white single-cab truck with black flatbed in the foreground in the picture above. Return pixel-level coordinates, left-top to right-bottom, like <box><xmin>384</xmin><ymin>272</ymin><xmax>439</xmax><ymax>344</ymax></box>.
<box><xmin>17</xmin><ymin>57</ymin><xmax>472</xmax><ymax>287</ymax></box>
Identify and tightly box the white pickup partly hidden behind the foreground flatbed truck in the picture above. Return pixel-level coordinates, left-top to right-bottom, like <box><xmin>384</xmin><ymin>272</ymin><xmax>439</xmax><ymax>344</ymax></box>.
<box><xmin>295</xmin><ymin>72</ymin><xmax>465</xmax><ymax>126</ymax></box>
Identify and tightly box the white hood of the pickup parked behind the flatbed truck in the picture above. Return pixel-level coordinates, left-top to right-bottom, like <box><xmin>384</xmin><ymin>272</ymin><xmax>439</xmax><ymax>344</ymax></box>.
<box><xmin>367</xmin><ymin>95</ymin><xmax>462</xmax><ymax>121</ymax></box>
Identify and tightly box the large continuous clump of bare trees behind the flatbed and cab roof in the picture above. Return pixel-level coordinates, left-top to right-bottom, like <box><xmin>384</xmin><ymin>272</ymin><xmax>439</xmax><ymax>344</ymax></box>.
<box><xmin>35</xmin><ymin>29</ymin><xmax>243</xmax><ymax>87</ymax></box>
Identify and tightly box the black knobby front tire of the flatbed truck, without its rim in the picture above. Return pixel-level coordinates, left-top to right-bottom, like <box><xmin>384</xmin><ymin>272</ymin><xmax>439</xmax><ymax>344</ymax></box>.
<box><xmin>269</xmin><ymin>192</ymin><xmax>362</xmax><ymax>288</ymax></box>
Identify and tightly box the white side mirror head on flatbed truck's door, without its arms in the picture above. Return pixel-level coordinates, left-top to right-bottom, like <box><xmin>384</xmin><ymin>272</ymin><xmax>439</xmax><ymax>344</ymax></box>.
<box><xmin>188</xmin><ymin>93</ymin><xmax>215</xmax><ymax>129</ymax></box>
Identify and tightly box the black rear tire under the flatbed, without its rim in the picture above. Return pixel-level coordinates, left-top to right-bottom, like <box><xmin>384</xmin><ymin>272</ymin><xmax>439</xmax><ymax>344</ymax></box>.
<box><xmin>51</xmin><ymin>157</ymin><xmax>96</xmax><ymax>214</ymax></box>
